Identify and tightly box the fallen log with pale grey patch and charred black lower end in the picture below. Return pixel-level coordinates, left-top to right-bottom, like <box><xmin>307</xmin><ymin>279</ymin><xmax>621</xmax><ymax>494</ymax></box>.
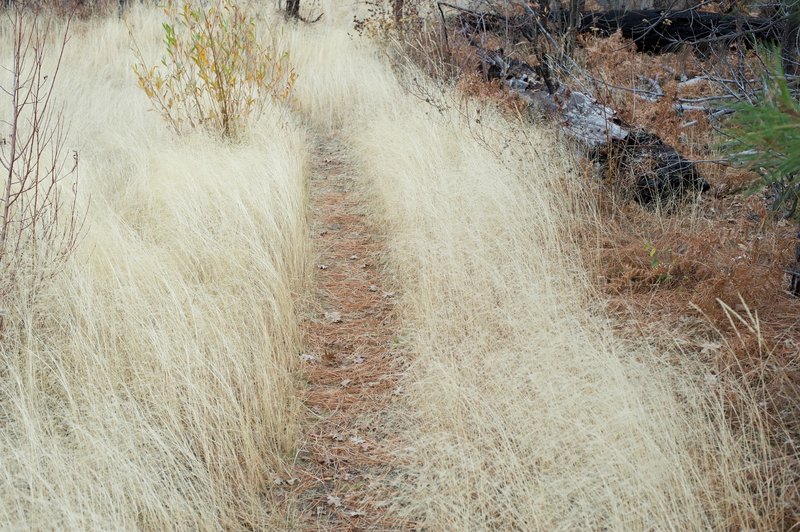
<box><xmin>477</xmin><ymin>47</ymin><xmax>709</xmax><ymax>204</ymax></box>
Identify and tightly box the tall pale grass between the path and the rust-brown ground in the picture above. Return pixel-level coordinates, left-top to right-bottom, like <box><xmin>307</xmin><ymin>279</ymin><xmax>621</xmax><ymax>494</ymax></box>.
<box><xmin>289</xmin><ymin>10</ymin><xmax>779</xmax><ymax>530</ymax></box>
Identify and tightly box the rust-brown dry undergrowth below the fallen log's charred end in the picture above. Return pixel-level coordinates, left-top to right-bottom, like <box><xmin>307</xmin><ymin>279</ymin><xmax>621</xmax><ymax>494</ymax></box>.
<box><xmin>586</xmin><ymin>174</ymin><xmax>800</xmax><ymax>527</ymax></box>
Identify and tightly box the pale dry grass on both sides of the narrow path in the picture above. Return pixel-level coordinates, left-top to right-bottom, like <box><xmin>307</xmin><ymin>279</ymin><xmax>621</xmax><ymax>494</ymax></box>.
<box><xmin>0</xmin><ymin>2</ymin><xmax>788</xmax><ymax>530</ymax></box>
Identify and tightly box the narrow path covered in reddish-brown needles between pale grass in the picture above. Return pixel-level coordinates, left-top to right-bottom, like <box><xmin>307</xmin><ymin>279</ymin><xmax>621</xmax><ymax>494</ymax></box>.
<box><xmin>296</xmin><ymin>131</ymin><xmax>400</xmax><ymax>530</ymax></box>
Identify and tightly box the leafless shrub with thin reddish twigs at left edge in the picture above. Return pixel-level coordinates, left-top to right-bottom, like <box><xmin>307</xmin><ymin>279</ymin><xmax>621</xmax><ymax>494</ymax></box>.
<box><xmin>0</xmin><ymin>6</ymin><xmax>83</xmax><ymax>302</ymax></box>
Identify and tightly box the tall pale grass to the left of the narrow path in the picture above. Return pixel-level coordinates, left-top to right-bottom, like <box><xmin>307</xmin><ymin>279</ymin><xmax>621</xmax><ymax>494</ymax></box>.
<box><xmin>0</xmin><ymin>9</ymin><xmax>308</xmax><ymax>530</ymax></box>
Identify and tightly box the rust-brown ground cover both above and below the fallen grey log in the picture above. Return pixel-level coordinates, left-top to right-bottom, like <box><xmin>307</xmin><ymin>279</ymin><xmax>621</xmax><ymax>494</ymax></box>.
<box><xmin>584</xmin><ymin>30</ymin><xmax>800</xmax><ymax>528</ymax></box>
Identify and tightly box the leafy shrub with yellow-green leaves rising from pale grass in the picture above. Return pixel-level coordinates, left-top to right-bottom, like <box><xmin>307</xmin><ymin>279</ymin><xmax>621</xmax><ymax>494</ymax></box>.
<box><xmin>133</xmin><ymin>0</ymin><xmax>295</xmax><ymax>138</ymax></box>
